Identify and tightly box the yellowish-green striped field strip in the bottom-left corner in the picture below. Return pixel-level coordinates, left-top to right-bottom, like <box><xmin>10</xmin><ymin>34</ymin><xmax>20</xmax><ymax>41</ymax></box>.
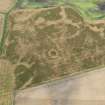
<box><xmin>0</xmin><ymin>59</ymin><xmax>14</xmax><ymax>105</ymax></box>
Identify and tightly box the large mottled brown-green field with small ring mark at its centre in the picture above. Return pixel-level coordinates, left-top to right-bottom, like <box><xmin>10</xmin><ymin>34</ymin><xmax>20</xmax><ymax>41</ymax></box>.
<box><xmin>4</xmin><ymin>6</ymin><xmax>105</xmax><ymax>89</ymax></box>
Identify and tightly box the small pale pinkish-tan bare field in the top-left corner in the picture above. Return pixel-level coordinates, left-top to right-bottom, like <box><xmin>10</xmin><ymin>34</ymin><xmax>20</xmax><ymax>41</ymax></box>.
<box><xmin>0</xmin><ymin>0</ymin><xmax>15</xmax><ymax>12</ymax></box>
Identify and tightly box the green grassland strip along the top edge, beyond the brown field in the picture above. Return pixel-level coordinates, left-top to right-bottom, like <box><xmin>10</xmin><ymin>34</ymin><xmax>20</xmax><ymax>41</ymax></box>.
<box><xmin>14</xmin><ymin>0</ymin><xmax>105</xmax><ymax>20</ymax></box>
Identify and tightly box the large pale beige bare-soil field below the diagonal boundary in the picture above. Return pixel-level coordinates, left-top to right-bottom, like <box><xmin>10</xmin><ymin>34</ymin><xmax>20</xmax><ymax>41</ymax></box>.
<box><xmin>15</xmin><ymin>68</ymin><xmax>105</xmax><ymax>105</ymax></box>
